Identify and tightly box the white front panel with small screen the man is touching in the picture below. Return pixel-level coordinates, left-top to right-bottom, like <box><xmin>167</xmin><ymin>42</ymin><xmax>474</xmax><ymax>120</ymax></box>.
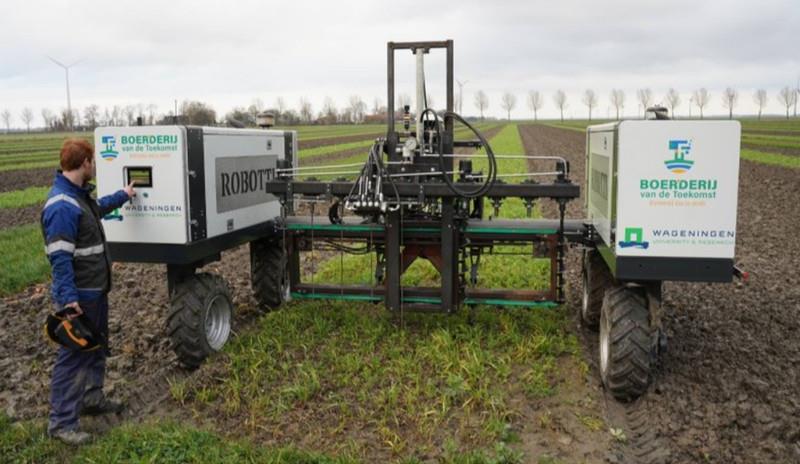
<box><xmin>94</xmin><ymin>126</ymin><xmax>189</xmax><ymax>244</ymax></box>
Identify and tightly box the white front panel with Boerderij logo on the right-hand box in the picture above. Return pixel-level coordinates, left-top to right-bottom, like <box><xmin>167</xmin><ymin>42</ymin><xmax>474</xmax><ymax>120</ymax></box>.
<box><xmin>615</xmin><ymin>121</ymin><xmax>741</xmax><ymax>258</ymax></box>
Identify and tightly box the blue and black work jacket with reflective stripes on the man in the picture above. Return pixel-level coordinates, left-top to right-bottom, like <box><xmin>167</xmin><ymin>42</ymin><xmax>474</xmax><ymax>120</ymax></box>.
<box><xmin>41</xmin><ymin>172</ymin><xmax>129</xmax><ymax>306</ymax></box>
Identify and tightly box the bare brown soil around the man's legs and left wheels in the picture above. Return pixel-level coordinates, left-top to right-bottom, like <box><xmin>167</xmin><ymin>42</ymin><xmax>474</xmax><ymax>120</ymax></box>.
<box><xmin>0</xmin><ymin>246</ymin><xmax>257</xmax><ymax>418</ymax></box>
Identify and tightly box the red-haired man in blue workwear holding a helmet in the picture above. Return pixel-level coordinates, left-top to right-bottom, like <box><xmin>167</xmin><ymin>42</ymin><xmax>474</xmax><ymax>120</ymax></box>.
<box><xmin>41</xmin><ymin>139</ymin><xmax>136</xmax><ymax>445</ymax></box>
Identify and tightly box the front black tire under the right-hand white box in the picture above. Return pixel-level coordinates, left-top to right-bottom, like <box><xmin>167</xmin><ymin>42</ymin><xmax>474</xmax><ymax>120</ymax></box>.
<box><xmin>600</xmin><ymin>286</ymin><xmax>653</xmax><ymax>401</ymax></box>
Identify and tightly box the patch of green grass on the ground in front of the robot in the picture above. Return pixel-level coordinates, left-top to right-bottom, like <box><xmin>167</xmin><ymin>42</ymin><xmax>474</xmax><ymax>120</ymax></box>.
<box><xmin>193</xmin><ymin>301</ymin><xmax>578</xmax><ymax>456</ymax></box>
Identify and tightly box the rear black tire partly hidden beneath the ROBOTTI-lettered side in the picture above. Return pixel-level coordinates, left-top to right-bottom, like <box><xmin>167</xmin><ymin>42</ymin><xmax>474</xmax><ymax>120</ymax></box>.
<box><xmin>250</xmin><ymin>238</ymin><xmax>289</xmax><ymax>312</ymax></box>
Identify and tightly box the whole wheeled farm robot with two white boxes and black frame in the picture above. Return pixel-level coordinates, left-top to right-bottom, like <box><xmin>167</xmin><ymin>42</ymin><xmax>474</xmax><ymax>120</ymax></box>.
<box><xmin>95</xmin><ymin>40</ymin><xmax>740</xmax><ymax>400</ymax></box>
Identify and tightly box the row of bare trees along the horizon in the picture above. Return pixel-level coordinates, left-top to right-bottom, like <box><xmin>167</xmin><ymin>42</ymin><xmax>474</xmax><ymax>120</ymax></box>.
<box><xmin>0</xmin><ymin>86</ymin><xmax>800</xmax><ymax>133</ymax></box>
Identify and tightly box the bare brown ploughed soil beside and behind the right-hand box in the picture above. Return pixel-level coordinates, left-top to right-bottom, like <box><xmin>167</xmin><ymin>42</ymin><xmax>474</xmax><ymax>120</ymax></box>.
<box><xmin>521</xmin><ymin>125</ymin><xmax>800</xmax><ymax>463</ymax></box>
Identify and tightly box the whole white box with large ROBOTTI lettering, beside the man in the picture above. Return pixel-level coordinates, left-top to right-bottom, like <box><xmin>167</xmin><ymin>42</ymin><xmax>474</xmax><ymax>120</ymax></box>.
<box><xmin>95</xmin><ymin>126</ymin><xmax>297</xmax><ymax>262</ymax></box>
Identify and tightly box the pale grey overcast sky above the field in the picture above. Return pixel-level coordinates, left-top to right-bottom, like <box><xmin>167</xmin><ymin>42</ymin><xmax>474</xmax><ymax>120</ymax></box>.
<box><xmin>0</xmin><ymin>0</ymin><xmax>800</xmax><ymax>126</ymax></box>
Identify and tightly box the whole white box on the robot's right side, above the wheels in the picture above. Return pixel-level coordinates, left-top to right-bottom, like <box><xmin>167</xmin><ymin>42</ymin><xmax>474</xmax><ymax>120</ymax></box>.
<box><xmin>586</xmin><ymin>120</ymin><xmax>741</xmax><ymax>281</ymax></box>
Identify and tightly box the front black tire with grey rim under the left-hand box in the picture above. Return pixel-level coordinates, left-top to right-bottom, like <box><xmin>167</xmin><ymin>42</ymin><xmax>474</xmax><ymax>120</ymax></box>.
<box><xmin>167</xmin><ymin>273</ymin><xmax>233</xmax><ymax>368</ymax></box>
